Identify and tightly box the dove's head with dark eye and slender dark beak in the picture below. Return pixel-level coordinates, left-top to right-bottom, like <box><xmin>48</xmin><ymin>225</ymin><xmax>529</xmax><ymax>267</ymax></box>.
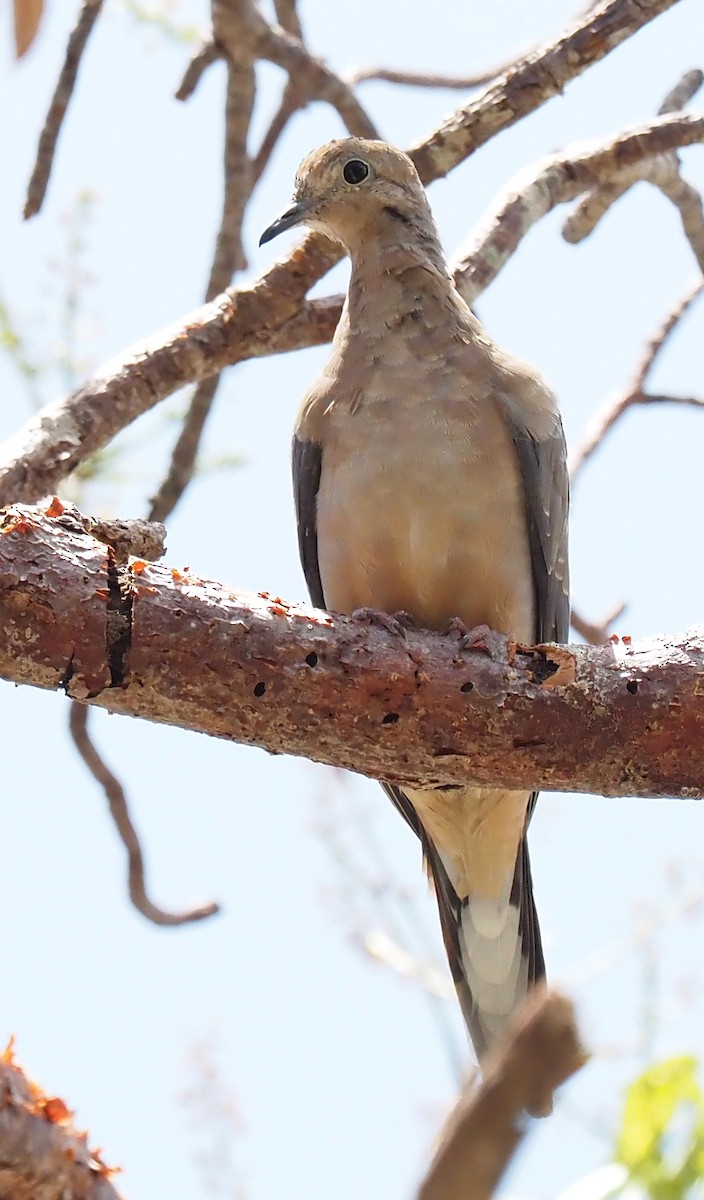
<box><xmin>259</xmin><ymin>138</ymin><xmax>433</xmax><ymax>251</ymax></box>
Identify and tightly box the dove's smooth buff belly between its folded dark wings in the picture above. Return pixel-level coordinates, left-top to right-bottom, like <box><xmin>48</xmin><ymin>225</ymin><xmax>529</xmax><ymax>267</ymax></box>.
<box><xmin>318</xmin><ymin>403</ymin><xmax>535</xmax><ymax>642</ymax></box>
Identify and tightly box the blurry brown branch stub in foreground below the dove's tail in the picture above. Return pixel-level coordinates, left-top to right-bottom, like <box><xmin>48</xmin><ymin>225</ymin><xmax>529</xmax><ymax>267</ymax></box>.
<box><xmin>417</xmin><ymin>992</ymin><xmax>586</xmax><ymax>1200</ymax></box>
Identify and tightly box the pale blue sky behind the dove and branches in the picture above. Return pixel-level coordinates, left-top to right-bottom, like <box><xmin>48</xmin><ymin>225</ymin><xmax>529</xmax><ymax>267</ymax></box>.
<box><xmin>0</xmin><ymin>0</ymin><xmax>704</xmax><ymax>1200</ymax></box>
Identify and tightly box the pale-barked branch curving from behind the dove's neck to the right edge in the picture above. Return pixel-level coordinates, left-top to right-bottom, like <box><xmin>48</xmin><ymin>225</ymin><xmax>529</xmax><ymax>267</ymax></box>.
<box><xmin>453</xmin><ymin>114</ymin><xmax>704</xmax><ymax>304</ymax></box>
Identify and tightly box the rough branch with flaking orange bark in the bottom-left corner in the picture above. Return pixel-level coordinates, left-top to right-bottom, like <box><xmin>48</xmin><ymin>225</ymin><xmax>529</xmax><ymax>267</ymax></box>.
<box><xmin>0</xmin><ymin>1045</ymin><xmax>120</xmax><ymax>1200</ymax></box>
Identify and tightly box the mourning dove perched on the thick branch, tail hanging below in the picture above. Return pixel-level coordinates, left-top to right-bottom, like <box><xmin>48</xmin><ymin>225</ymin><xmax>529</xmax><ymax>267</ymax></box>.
<box><xmin>261</xmin><ymin>138</ymin><xmax>568</xmax><ymax>1062</ymax></box>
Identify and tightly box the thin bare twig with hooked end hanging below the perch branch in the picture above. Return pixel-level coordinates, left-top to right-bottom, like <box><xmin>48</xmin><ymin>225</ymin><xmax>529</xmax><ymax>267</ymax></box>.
<box><xmin>68</xmin><ymin>701</ymin><xmax>219</xmax><ymax>925</ymax></box>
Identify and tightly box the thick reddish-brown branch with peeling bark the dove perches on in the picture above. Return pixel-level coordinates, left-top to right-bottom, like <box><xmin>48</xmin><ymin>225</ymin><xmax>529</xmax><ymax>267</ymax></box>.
<box><xmin>0</xmin><ymin>504</ymin><xmax>704</xmax><ymax>797</ymax></box>
